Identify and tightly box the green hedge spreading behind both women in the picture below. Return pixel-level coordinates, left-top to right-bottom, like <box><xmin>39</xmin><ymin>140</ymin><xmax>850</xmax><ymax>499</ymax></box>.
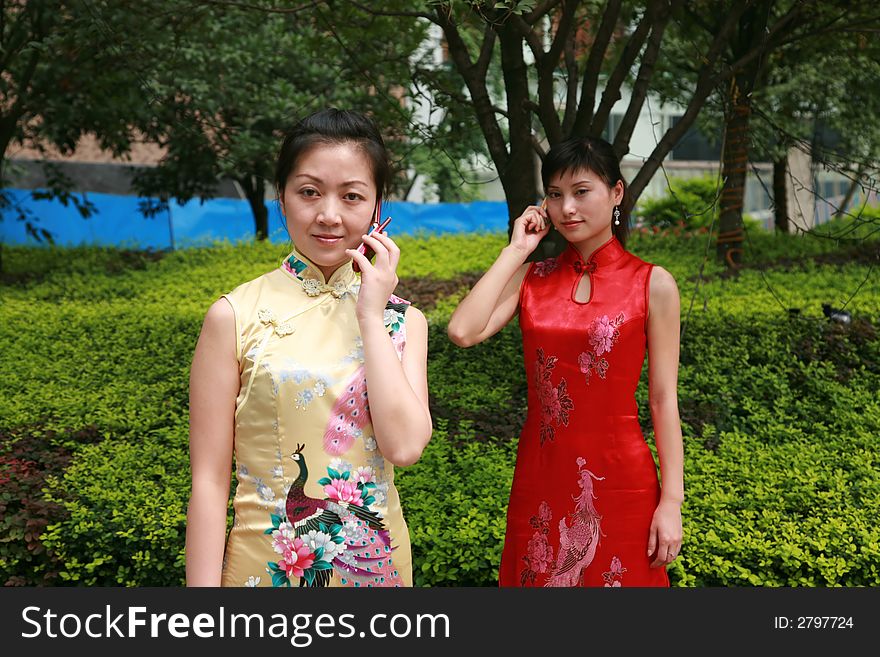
<box><xmin>0</xmin><ymin>226</ymin><xmax>880</xmax><ymax>586</ymax></box>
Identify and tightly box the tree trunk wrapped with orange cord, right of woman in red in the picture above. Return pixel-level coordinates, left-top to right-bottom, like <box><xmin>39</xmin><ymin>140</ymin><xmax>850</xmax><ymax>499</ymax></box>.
<box><xmin>717</xmin><ymin>76</ymin><xmax>752</xmax><ymax>269</ymax></box>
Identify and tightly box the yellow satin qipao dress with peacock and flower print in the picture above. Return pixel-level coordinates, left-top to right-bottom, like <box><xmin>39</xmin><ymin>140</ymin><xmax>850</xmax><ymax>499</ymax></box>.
<box><xmin>222</xmin><ymin>250</ymin><xmax>412</xmax><ymax>587</ymax></box>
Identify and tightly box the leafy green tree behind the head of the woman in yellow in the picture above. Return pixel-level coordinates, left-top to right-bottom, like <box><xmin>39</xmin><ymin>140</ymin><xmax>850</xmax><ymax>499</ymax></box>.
<box><xmin>131</xmin><ymin>1</ymin><xmax>424</xmax><ymax>239</ymax></box>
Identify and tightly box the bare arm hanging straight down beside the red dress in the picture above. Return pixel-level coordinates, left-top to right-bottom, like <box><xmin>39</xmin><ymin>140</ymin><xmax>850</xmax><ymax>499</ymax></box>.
<box><xmin>648</xmin><ymin>267</ymin><xmax>684</xmax><ymax>566</ymax></box>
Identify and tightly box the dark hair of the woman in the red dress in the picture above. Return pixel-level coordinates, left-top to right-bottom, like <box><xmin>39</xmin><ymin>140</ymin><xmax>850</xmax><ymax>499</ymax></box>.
<box><xmin>541</xmin><ymin>137</ymin><xmax>629</xmax><ymax>246</ymax></box>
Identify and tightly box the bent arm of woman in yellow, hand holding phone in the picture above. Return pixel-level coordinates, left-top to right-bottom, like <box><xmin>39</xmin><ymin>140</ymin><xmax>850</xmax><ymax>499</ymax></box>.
<box><xmin>348</xmin><ymin>232</ymin><xmax>433</xmax><ymax>466</ymax></box>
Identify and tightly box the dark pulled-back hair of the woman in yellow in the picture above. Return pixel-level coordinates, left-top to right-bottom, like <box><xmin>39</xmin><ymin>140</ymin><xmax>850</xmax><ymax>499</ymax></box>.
<box><xmin>275</xmin><ymin>107</ymin><xmax>391</xmax><ymax>199</ymax></box>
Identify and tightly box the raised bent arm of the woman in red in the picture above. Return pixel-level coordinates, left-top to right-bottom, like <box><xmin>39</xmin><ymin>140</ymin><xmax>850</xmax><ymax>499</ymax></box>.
<box><xmin>446</xmin><ymin>206</ymin><xmax>548</xmax><ymax>347</ymax></box>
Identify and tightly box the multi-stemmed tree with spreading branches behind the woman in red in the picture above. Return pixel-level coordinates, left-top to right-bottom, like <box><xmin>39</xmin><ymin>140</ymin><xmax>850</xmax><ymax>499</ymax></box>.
<box><xmin>352</xmin><ymin>0</ymin><xmax>776</xmax><ymax>219</ymax></box>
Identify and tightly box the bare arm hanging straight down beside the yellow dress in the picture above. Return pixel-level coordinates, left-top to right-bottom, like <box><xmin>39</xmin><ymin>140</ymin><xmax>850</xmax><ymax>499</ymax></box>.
<box><xmin>186</xmin><ymin>299</ymin><xmax>239</xmax><ymax>586</ymax></box>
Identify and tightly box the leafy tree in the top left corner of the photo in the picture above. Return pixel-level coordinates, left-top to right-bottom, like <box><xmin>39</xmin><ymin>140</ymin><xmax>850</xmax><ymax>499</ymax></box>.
<box><xmin>0</xmin><ymin>0</ymin><xmax>151</xmax><ymax>269</ymax></box>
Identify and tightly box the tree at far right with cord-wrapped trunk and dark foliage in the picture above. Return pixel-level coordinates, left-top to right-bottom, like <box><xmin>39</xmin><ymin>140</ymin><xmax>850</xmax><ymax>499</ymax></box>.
<box><xmin>666</xmin><ymin>0</ymin><xmax>880</xmax><ymax>267</ymax></box>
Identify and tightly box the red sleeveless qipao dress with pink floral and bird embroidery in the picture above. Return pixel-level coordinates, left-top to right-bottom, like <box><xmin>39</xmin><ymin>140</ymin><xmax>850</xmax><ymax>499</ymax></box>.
<box><xmin>499</xmin><ymin>237</ymin><xmax>669</xmax><ymax>586</ymax></box>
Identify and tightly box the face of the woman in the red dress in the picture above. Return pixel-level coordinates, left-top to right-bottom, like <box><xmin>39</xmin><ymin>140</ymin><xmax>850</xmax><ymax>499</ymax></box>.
<box><xmin>547</xmin><ymin>169</ymin><xmax>623</xmax><ymax>247</ymax></box>
